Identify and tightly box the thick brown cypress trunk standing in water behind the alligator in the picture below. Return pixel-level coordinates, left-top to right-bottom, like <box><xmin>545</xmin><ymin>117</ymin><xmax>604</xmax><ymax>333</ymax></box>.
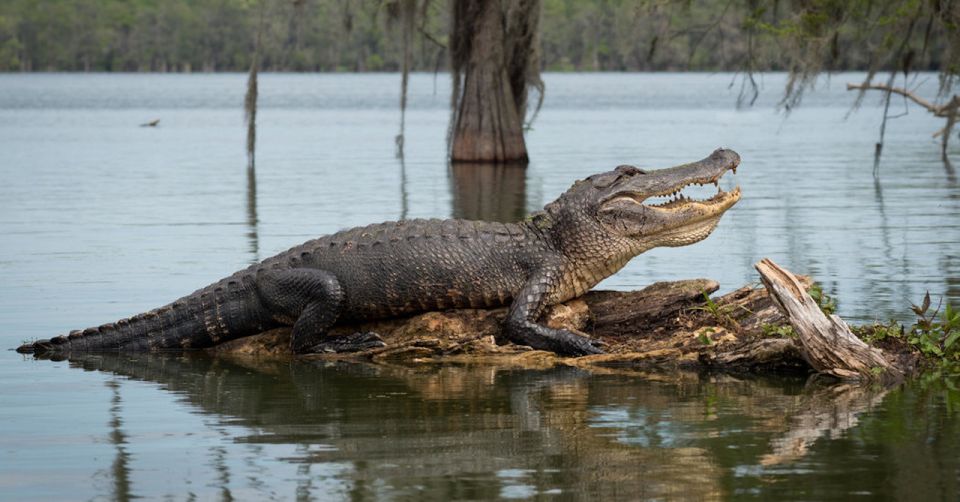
<box><xmin>450</xmin><ymin>0</ymin><xmax>540</xmax><ymax>162</ymax></box>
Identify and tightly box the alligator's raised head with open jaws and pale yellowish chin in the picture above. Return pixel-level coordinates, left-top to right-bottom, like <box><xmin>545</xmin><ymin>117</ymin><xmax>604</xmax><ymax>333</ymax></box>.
<box><xmin>545</xmin><ymin>149</ymin><xmax>740</xmax><ymax>254</ymax></box>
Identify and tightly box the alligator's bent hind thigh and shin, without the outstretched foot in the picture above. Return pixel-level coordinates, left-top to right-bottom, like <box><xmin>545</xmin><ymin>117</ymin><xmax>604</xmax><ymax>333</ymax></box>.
<box><xmin>257</xmin><ymin>268</ymin><xmax>343</xmax><ymax>354</ymax></box>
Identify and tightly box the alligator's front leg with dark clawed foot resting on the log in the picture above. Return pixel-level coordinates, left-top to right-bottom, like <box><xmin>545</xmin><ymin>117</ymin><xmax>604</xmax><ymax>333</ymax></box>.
<box><xmin>504</xmin><ymin>267</ymin><xmax>603</xmax><ymax>356</ymax></box>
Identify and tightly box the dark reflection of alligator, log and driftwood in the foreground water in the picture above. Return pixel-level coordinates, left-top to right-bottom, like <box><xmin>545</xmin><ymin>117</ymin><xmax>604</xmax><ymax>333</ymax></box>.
<box><xmin>62</xmin><ymin>355</ymin><xmax>928</xmax><ymax>499</ymax></box>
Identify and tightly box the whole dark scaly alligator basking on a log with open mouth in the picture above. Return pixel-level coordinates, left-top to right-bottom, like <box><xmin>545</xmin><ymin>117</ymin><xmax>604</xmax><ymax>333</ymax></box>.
<box><xmin>17</xmin><ymin>149</ymin><xmax>740</xmax><ymax>356</ymax></box>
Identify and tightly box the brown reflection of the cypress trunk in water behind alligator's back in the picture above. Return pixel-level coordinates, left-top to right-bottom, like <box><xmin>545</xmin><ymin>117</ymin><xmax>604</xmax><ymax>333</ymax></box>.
<box><xmin>450</xmin><ymin>162</ymin><xmax>527</xmax><ymax>222</ymax></box>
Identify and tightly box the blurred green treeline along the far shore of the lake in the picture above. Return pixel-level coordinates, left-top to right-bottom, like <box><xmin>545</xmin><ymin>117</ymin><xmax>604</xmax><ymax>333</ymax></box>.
<box><xmin>0</xmin><ymin>0</ymin><xmax>950</xmax><ymax>72</ymax></box>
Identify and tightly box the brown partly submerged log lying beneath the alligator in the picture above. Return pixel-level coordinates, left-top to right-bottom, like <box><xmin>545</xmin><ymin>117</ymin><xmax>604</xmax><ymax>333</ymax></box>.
<box><xmin>210</xmin><ymin>264</ymin><xmax>916</xmax><ymax>377</ymax></box>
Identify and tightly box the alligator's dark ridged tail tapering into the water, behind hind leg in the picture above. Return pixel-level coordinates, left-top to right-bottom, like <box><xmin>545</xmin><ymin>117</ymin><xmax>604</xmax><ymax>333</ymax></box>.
<box><xmin>17</xmin><ymin>277</ymin><xmax>275</xmax><ymax>355</ymax></box>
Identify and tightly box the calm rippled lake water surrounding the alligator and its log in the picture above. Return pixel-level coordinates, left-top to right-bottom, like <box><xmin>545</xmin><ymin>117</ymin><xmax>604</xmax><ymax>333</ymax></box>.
<box><xmin>0</xmin><ymin>74</ymin><xmax>960</xmax><ymax>500</ymax></box>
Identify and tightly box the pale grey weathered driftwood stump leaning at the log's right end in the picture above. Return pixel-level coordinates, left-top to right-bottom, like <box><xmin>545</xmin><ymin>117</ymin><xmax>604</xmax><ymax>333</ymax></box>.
<box><xmin>755</xmin><ymin>259</ymin><xmax>903</xmax><ymax>380</ymax></box>
